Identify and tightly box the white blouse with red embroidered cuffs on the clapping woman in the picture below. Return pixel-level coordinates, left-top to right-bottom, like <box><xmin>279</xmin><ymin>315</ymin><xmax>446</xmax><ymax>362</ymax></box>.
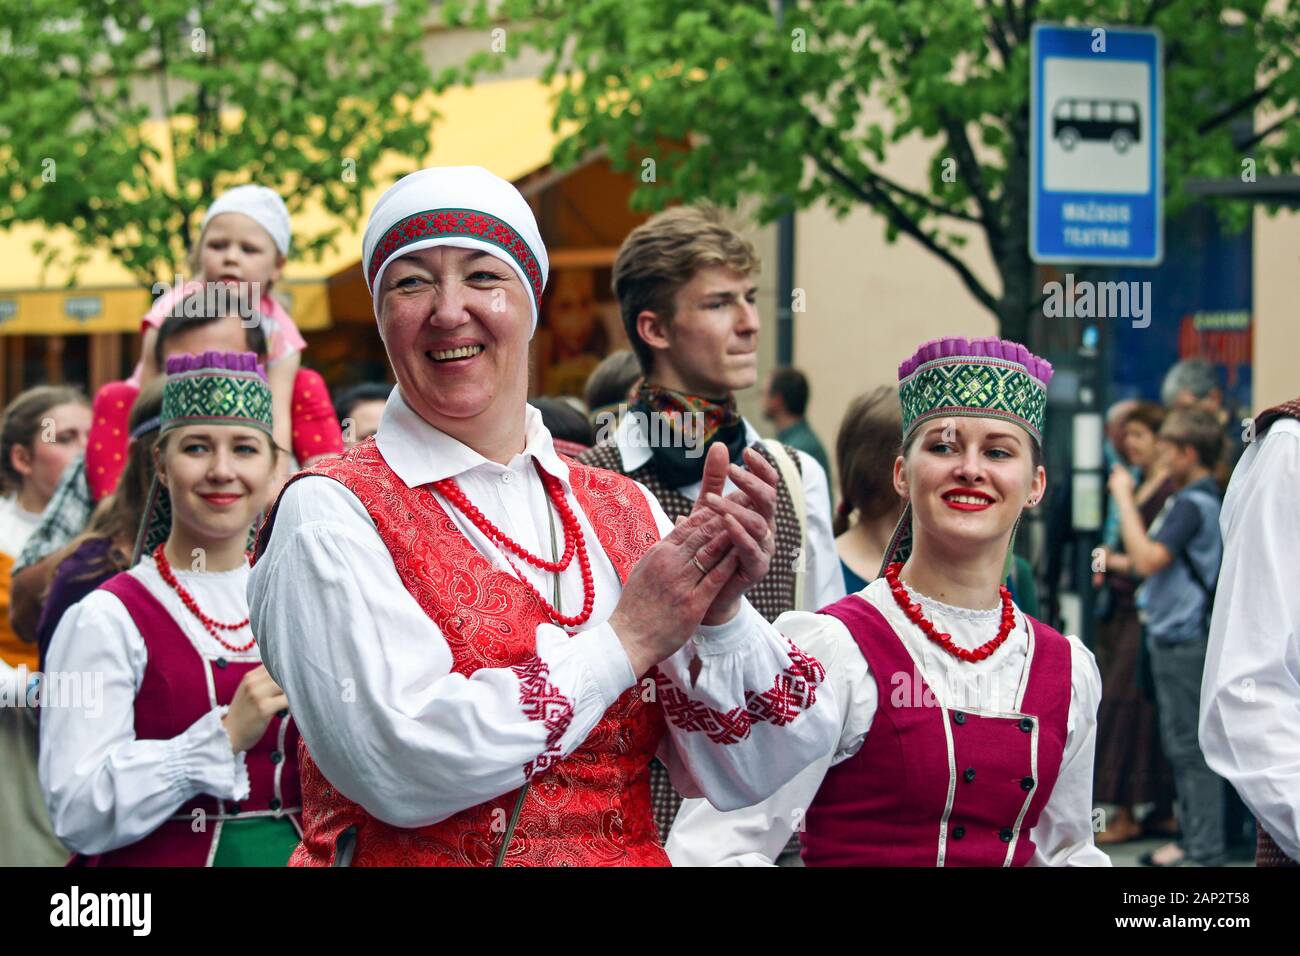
<box><xmin>248</xmin><ymin>389</ymin><xmax>839</xmax><ymax>827</ymax></box>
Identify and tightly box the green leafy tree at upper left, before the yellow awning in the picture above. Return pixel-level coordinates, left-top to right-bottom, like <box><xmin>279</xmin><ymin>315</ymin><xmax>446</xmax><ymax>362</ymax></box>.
<box><xmin>0</xmin><ymin>0</ymin><xmax>432</xmax><ymax>285</ymax></box>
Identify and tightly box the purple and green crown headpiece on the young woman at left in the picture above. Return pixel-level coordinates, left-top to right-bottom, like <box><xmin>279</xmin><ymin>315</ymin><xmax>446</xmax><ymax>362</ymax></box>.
<box><xmin>161</xmin><ymin>351</ymin><xmax>274</xmax><ymax>436</ymax></box>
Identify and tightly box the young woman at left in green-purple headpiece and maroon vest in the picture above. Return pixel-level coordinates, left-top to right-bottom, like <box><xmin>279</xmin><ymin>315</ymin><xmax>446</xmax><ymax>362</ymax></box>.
<box><xmin>40</xmin><ymin>352</ymin><xmax>302</xmax><ymax>866</ymax></box>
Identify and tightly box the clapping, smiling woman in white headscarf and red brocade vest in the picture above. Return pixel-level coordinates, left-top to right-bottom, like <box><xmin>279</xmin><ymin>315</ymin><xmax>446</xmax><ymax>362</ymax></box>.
<box><xmin>250</xmin><ymin>166</ymin><xmax>839</xmax><ymax>866</ymax></box>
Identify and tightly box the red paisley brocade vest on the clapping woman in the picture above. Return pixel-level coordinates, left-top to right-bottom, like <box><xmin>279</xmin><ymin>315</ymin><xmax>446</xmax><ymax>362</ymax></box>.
<box><xmin>257</xmin><ymin>440</ymin><xmax>668</xmax><ymax>866</ymax></box>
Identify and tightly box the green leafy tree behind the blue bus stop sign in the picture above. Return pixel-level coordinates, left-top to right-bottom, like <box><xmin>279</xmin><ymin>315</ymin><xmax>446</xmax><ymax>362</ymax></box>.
<box><xmin>441</xmin><ymin>0</ymin><xmax>1300</xmax><ymax>341</ymax></box>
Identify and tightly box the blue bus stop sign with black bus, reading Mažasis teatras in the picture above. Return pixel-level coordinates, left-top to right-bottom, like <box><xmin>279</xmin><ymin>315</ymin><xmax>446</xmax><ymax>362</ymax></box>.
<box><xmin>1030</xmin><ymin>23</ymin><xmax>1165</xmax><ymax>265</ymax></box>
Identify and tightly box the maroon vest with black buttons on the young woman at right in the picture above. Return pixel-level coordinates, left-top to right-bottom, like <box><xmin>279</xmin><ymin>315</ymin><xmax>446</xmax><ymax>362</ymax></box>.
<box><xmin>801</xmin><ymin>594</ymin><xmax>1070</xmax><ymax>866</ymax></box>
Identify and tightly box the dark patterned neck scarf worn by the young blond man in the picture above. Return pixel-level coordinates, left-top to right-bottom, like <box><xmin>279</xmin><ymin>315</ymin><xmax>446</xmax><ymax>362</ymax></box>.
<box><xmin>632</xmin><ymin>382</ymin><xmax>745</xmax><ymax>488</ymax></box>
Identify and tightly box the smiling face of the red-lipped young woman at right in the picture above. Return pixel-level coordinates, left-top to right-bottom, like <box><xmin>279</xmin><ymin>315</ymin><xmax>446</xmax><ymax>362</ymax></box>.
<box><xmin>894</xmin><ymin>418</ymin><xmax>1047</xmax><ymax>549</ymax></box>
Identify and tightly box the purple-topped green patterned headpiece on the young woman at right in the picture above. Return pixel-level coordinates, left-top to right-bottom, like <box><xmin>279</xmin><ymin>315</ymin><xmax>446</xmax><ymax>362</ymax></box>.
<box><xmin>898</xmin><ymin>337</ymin><xmax>1052</xmax><ymax>445</ymax></box>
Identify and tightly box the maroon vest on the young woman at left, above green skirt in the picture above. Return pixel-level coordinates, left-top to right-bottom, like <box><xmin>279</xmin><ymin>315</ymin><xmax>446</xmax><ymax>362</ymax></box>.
<box><xmin>72</xmin><ymin>572</ymin><xmax>302</xmax><ymax>866</ymax></box>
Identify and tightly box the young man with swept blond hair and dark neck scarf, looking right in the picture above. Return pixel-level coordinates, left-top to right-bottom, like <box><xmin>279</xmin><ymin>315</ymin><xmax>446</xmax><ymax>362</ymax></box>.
<box><xmin>580</xmin><ymin>206</ymin><xmax>845</xmax><ymax>839</ymax></box>
